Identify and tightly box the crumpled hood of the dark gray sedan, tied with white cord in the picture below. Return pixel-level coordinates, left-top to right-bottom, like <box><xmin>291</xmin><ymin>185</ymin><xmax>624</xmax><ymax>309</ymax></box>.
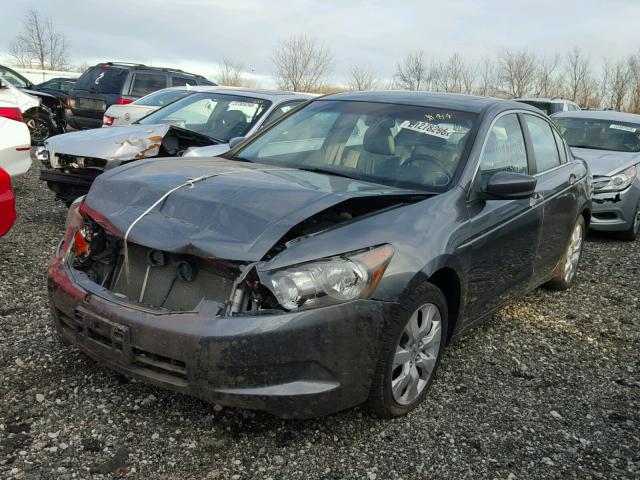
<box><xmin>82</xmin><ymin>158</ymin><xmax>416</xmax><ymax>261</ymax></box>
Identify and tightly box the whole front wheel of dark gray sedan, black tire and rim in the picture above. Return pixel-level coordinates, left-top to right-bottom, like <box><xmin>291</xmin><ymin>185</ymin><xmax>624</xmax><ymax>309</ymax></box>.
<box><xmin>367</xmin><ymin>283</ymin><xmax>448</xmax><ymax>418</ymax></box>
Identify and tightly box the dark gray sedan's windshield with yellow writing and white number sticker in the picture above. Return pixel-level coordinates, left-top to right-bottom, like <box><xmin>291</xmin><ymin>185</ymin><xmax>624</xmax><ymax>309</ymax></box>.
<box><xmin>232</xmin><ymin>100</ymin><xmax>476</xmax><ymax>191</ymax></box>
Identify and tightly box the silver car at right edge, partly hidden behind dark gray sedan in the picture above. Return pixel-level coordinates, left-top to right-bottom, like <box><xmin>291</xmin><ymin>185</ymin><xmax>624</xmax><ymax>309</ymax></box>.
<box><xmin>553</xmin><ymin>110</ymin><xmax>640</xmax><ymax>240</ymax></box>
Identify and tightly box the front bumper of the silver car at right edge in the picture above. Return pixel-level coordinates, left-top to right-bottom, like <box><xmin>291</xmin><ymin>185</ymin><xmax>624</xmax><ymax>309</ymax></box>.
<box><xmin>589</xmin><ymin>179</ymin><xmax>640</xmax><ymax>232</ymax></box>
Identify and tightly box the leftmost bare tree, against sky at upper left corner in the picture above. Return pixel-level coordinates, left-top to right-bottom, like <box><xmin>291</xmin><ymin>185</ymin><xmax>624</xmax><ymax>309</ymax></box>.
<box><xmin>9</xmin><ymin>10</ymin><xmax>69</xmax><ymax>70</ymax></box>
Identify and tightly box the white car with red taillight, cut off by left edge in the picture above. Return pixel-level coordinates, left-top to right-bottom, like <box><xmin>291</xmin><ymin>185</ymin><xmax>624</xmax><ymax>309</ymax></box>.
<box><xmin>0</xmin><ymin>100</ymin><xmax>31</xmax><ymax>177</ymax></box>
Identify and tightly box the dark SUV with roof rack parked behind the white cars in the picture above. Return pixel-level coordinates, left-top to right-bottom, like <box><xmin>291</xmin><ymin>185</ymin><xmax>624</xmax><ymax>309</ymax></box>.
<box><xmin>67</xmin><ymin>62</ymin><xmax>215</xmax><ymax>129</ymax></box>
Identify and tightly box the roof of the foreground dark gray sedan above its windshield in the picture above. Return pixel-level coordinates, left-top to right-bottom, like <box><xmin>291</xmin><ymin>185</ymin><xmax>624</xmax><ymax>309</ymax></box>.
<box><xmin>318</xmin><ymin>90</ymin><xmax>538</xmax><ymax>113</ymax></box>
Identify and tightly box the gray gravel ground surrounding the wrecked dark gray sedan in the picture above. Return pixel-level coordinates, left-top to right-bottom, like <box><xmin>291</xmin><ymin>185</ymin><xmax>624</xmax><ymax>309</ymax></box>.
<box><xmin>0</xmin><ymin>169</ymin><xmax>640</xmax><ymax>480</ymax></box>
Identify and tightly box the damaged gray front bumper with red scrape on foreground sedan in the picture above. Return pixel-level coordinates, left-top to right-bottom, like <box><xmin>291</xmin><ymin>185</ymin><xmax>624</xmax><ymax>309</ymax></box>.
<box><xmin>49</xmin><ymin>249</ymin><xmax>394</xmax><ymax>418</ymax></box>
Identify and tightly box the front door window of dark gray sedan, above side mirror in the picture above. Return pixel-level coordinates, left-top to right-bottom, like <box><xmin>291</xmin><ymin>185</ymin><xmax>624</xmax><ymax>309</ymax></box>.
<box><xmin>480</xmin><ymin>114</ymin><xmax>529</xmax><ymax>185</ymax></box>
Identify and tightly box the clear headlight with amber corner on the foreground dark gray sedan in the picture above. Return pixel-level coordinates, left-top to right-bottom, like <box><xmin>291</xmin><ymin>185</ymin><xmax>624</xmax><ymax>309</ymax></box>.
<box><xmin>260</xmin><ymin>245</ymin><xmax>393</xmax><ymax>310</ymax></box>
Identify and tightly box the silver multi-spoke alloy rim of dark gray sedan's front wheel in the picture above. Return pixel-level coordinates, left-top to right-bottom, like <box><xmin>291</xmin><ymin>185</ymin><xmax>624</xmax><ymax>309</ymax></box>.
<box><xmin>391</xmin><ymin>303</ymin><xmax>442</xmax><ymax>405</ymax></box>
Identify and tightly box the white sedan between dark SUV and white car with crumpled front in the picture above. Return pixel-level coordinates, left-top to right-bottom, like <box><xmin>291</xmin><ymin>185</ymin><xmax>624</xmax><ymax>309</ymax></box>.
<box><xmin>102</xmin><ymin>85</ymin><xmax>192</xmax><ymax>127</ymax></box>
